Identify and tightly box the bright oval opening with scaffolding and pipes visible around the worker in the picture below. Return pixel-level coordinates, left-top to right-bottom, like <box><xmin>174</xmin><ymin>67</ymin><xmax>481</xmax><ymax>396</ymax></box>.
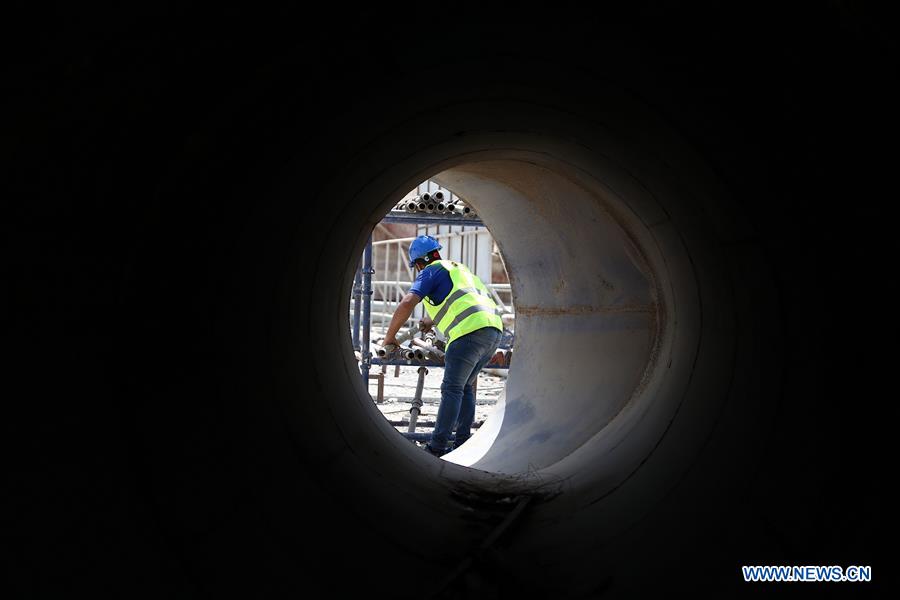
<box><xmin>349</xmin><ymin>180</ymin><xmax>515</xmax><ymax>464</ymax></box>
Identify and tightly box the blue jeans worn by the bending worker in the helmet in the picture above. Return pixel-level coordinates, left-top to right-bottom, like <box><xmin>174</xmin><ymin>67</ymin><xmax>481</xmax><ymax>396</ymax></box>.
<box><xmin>428</xmin><ymin>327</ymin><xmax>502</xmax><ymax>452</ymax></box>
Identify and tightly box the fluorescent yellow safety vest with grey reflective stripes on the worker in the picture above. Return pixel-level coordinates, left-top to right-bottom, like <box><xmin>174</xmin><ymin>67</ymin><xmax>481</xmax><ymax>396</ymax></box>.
<box><xmin>424</xmin><ymin>260</ymin><xmax>503</xmax><ymax>348</ymax></box>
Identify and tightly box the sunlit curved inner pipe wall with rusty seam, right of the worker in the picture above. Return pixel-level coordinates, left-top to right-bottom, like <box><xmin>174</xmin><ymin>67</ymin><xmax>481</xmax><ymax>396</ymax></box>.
<box><xmin>334</xmin><ymin>151</ymin><xmax>666</xmax><ymax>478</ymax></box>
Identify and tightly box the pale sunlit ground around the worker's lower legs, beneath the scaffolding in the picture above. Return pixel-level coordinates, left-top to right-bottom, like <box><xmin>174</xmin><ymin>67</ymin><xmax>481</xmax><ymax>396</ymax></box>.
<box><xmin>369</xmin><ymin>366</ymin><xmax>506</xmax><ymax>446</ymax></box>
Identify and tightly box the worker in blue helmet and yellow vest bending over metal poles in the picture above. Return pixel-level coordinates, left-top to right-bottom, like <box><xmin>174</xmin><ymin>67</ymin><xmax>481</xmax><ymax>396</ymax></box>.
<box><xmin>383</xmin><ymin>235</ymin><xmax>503</xmax><ymax>456</ymax></box>
